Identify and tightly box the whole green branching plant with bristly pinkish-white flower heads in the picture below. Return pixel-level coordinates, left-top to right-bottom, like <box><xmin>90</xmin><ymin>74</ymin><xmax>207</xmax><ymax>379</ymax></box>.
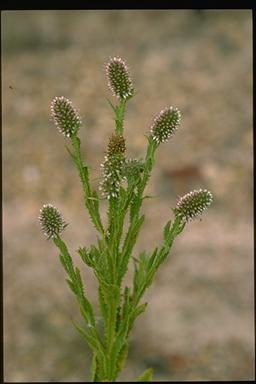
<box><xmin>39</xmin><ymin>57</ymin><xmax>212</xmax><ymax>382</ymax></box>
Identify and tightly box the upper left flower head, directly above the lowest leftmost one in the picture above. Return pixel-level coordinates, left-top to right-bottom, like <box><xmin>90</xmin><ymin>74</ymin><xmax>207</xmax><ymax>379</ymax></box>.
<box><xmin>51</xmin><ymin>96</ymin><xmax>81</xmax><ymax>137</ymax></box>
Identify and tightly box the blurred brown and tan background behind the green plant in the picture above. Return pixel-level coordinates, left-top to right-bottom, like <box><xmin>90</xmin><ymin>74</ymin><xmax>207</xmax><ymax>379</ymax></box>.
<box><xmin>2</xmin><ymin>10</ymin><xmax>254</xmax><ymax>382</ymax></box>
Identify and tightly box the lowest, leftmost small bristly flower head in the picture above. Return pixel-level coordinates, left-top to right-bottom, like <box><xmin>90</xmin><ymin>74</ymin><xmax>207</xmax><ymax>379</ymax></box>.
<box><xmin>39</xmin><ymin>204</ymin><xmax>68</xmax><ymax>238</ymax></box>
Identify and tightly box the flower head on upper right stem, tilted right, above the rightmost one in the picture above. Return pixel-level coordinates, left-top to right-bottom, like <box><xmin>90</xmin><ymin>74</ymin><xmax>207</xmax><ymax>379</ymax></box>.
<box><xmin>151</xmin><ymin>107</ymin><xmax>181</xmax><ymax>144</ymax></box>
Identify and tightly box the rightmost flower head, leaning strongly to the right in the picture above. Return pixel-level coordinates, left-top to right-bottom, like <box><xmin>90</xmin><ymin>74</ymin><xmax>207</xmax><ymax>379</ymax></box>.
<box><xmin>174</xmin><ymin>189</ymin><xmax>213</xmax><ymax>222</ymax></box>
